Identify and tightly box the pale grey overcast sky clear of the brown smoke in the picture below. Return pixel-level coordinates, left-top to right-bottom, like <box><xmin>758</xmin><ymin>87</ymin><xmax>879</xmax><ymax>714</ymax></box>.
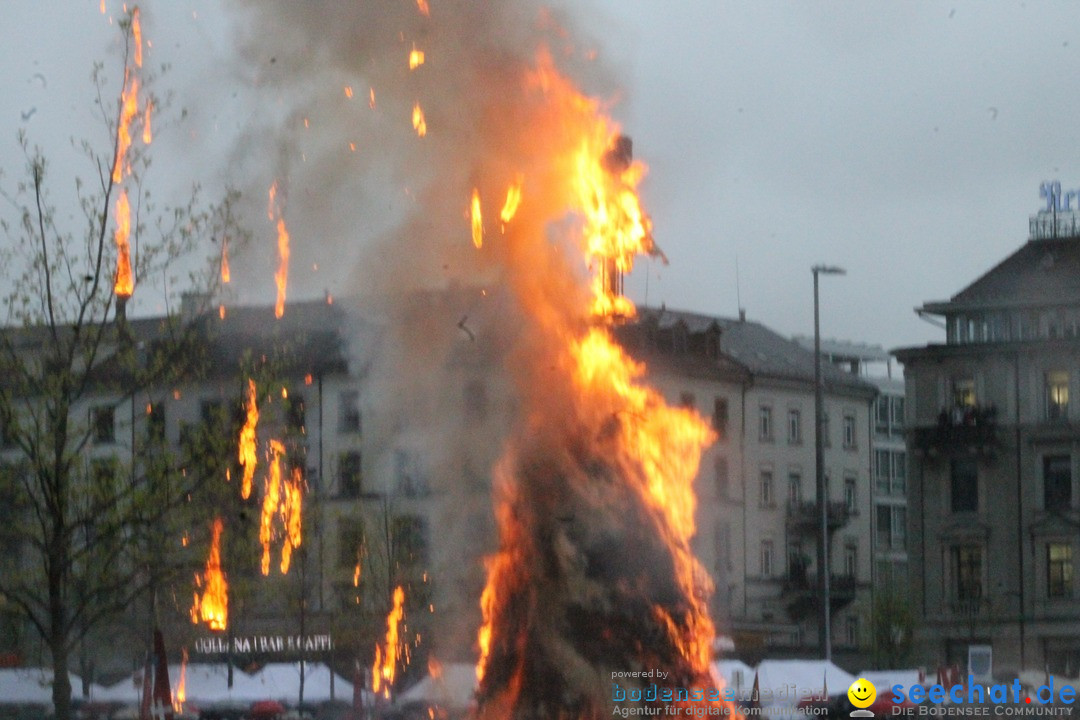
<box><xmin>0</xmin><ymin>0</ymin><xmax>1080</xmax><ymax>358</ymax></box>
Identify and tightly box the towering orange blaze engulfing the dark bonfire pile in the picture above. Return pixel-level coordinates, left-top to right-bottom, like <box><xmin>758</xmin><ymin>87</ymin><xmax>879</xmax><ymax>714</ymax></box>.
<box><xmin>476</xmin><ymin>51</ymin><xmax>715</xmax><ymax>720</ymax></box>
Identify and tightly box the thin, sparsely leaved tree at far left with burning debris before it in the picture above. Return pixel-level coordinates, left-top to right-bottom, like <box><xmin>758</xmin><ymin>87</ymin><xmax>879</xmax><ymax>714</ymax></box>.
<box><xmin>0</xmin><ymin>10</ymin><xmax>243</xmax><ymax>720</ymax></box>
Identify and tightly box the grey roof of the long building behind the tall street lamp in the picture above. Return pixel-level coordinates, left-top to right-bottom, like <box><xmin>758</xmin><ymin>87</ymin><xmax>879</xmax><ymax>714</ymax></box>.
<box><xmin>621</xmin><ymin>308</ymin><xmax>876</xmax><ymax>395</ymax></box>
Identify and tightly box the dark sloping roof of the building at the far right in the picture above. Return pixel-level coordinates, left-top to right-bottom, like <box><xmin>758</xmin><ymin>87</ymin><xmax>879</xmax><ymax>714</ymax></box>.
<box><xmin>924</xmin><ymin>237</ymin><xmax>1080</xmax><ymax>314</ymax></box>
